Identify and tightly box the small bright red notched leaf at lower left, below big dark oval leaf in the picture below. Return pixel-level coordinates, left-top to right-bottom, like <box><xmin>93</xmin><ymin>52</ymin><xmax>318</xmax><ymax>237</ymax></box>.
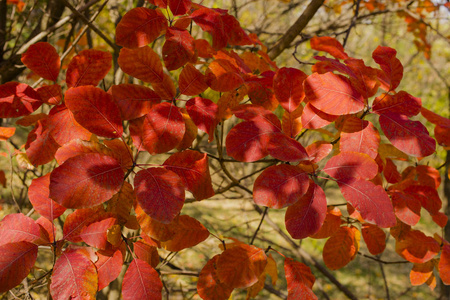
<box><xmin>80</xmin><ymin>218</ymin><xmax>117</xmax><ymax>249</ymax></box>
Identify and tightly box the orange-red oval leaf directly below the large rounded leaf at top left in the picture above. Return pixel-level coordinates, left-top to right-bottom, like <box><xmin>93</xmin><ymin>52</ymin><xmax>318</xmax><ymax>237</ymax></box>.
<box><xmin>117</xmin><ymin>46</ymin><xmax>164</xmax><ymax>83</ymax></box>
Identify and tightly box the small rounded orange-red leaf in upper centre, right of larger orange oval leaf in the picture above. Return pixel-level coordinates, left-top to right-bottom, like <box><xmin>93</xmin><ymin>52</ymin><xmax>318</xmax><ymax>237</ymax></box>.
<box><xmin>178</xmin><ymin>63</ymin><xmax>208</xmax><ymax>96</ymax></box>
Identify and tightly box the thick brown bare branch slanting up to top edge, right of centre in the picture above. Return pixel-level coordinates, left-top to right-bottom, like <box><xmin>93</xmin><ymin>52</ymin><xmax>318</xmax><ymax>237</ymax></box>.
<box><xmin>269</xmin><ymin>0</ymin><xmax>324</xmax><ymax>59</ymax></box>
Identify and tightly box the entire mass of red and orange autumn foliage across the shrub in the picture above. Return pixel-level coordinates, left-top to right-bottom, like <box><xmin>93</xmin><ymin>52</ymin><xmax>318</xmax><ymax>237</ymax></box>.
<box><xmin>0</xmin><ymin>0</ymin><xmax>450</xmax><ymax>300</ymax></box>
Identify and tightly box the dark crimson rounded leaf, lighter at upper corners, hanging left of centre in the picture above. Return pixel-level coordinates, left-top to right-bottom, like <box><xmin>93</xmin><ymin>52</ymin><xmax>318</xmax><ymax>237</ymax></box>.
<box><xmin>134</xmin><ymin>168</ymin><xmax>184</xmax><ymax>224</ymax></box>
